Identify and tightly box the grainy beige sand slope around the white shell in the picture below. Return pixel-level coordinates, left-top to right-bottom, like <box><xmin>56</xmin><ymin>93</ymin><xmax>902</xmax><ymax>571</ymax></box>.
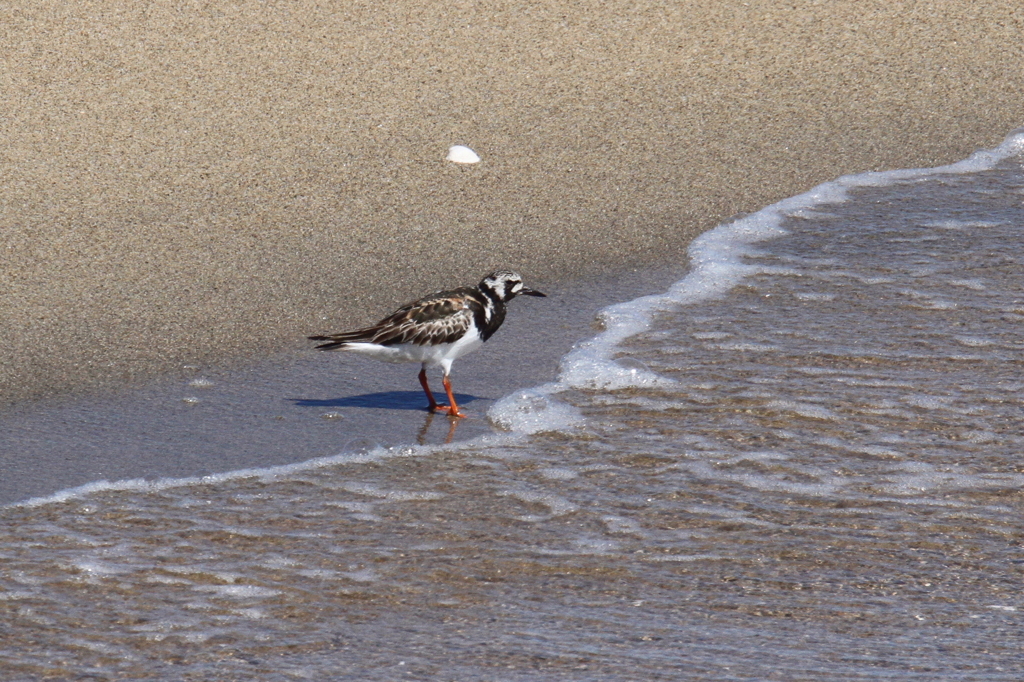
<box><xmin>0</xmin><ymin>0</ymin><xmax>1024</xmax><ymax>400</ymax></box>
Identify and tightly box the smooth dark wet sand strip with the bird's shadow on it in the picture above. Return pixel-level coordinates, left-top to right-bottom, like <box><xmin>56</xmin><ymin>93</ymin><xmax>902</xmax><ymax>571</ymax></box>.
<box><xmin>0</xmin><ymin>266</ymin><xmax>684</xmax><ymax>507</ymax></box>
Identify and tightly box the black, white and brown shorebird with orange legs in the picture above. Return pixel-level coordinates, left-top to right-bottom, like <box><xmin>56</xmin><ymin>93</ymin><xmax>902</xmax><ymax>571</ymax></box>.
<box><xmin>309</xmin><ymin>270</ymin><xmax>546</xmax><ymax>417</ymax></box>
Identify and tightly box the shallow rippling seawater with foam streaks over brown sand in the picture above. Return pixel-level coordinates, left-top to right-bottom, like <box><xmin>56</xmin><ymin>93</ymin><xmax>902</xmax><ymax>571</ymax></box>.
<box><xmin>0</xmin><ymin>142</ymin><xmax>1024</xmax><ymax>680</ymax></box>
